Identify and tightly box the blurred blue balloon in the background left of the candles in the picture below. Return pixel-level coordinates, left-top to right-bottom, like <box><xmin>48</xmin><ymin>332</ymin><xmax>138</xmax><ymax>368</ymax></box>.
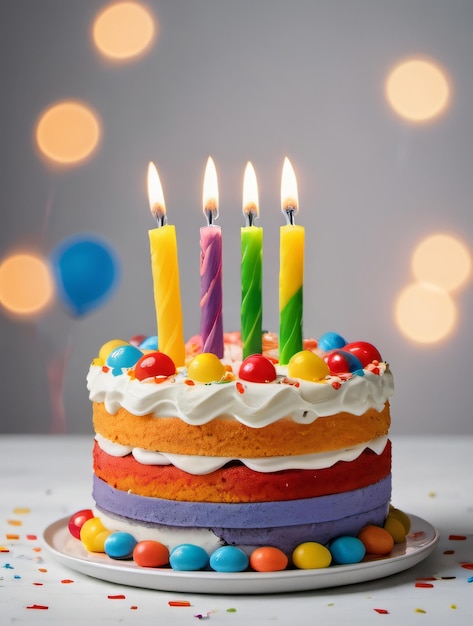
<box><xmin>51</xmin><ymin>235</ymin><xmax>120</xmax><ymax>317</ymax></box>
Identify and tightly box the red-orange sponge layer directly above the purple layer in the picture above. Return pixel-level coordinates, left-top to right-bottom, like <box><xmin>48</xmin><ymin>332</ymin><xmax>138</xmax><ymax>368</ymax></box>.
<box><xmin>93</xmin><ymin>441</ymin><xmax>391</xmax><ymax>503</ymax></box>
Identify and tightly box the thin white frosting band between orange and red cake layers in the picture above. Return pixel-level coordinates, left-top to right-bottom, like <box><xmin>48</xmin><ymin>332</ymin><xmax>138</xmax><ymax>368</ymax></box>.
<box><xmin>95</xmin><ymin>434</ymin><xmax>388</xmax><ymax>475</ymax></box>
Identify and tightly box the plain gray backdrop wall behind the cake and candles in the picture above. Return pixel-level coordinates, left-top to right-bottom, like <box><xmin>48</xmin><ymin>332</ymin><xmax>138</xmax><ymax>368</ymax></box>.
<box><xmin>0</xmin><ymin>0</ymin><xmax>473</xmax><ymax>434</ymax></box>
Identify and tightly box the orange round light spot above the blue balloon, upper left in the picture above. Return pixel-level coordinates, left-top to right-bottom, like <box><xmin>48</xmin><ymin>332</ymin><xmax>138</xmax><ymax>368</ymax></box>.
<box><xmin>36</xmin><ymin>100</ymin><xmax>100</xmax><ymax>165</ymax></box>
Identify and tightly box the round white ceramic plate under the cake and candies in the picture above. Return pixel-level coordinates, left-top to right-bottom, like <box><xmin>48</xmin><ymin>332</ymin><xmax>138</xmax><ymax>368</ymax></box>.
<box><xmin>43</xmin><ymin>515</ymin><xmax>439</xmax><ymax>595</ymax></box>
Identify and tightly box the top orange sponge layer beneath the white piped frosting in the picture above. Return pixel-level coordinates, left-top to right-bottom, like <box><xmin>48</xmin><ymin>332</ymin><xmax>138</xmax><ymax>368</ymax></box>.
<box><xmin>93</xmin><ymin>402</ymin><xmax>390</xmax><ymax>458</ymax></box>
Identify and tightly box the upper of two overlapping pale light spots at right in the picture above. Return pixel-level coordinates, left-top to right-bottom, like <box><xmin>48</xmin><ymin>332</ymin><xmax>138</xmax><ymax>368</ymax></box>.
<box><xmin>412</xmin><ymin>234</ymin><xmax>471</xmax><ymax>291</ymax></box>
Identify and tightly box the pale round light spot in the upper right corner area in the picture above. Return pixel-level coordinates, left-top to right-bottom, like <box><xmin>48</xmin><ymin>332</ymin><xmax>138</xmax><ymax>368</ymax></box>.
<box><xmin>386</xmin><ymin>59</ymin><xmax>450</xmax><ymax>122</ymax></box>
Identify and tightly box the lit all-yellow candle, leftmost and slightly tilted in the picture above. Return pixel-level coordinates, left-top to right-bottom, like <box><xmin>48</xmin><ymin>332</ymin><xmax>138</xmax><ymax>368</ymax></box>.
<box><xmin>148</xmin><ymin>163</ymin><xmax>185</xmax><ymax>367</ymax></box>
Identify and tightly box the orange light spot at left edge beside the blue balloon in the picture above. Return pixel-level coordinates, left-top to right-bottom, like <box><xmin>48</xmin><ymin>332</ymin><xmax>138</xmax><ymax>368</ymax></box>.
<box><xmin>0</xmin><ymin>254</ymin><xmax>54</xmax><ymax>316</ymax></box>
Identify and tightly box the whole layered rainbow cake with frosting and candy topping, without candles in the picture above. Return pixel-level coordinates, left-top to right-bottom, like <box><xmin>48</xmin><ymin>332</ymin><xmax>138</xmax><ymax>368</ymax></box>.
<box><xmin>87</xmin><ymin>333</ymin><xmax>393</xmax><ymax>555</ymax></box>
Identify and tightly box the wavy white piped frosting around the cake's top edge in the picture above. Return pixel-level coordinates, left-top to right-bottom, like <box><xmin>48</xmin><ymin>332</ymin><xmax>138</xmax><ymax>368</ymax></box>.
<box><xmin>87</xmin><ymin>363</ymin><xmax>394</xmax><ymax>428</ymax></box>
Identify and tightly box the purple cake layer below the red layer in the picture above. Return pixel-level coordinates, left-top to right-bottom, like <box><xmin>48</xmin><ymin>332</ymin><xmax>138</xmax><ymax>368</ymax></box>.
<box><xmin>93</xmin><ymin>476</ymin><xmax>391</xmax><ymax>533</ymax></box>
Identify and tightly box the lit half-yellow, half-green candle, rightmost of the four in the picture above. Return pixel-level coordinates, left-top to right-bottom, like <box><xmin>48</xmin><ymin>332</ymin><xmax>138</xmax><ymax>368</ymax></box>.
<box><xmin>279</xmin><ymin>157</ymin><xmax>304</xmax><ymax>365</ymax></box>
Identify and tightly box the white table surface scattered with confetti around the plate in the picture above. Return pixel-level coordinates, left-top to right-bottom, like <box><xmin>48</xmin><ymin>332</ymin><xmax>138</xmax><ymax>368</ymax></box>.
<box><xmin>0</xmin><ymin>435</ymin><xmax>473</xmax><ymax>626</ymax></box>
